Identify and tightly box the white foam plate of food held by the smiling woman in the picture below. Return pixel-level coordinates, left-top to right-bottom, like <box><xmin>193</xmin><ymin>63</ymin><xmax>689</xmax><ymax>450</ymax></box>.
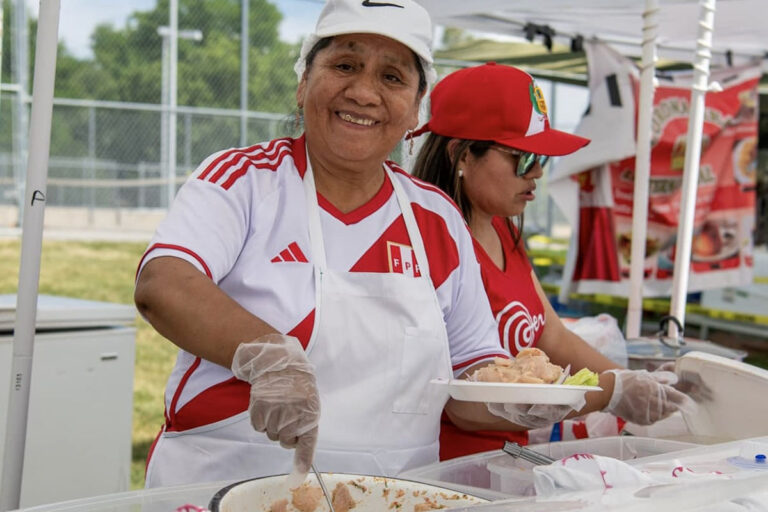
<box><xmin>431</xmin><ymin>379</ymin><xmax>602</xmax><ymax>405</ymax></box>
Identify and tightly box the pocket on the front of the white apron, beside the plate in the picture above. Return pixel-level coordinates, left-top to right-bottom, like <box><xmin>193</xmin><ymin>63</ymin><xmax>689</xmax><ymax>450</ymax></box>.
<box><xmin>392</xmin><ymin>327</ymin><xmax>447</xmax><ymax>414</ymax></box>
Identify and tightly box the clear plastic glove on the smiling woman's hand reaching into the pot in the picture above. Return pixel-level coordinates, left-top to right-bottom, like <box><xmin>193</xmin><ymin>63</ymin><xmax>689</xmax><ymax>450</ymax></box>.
<box><xmin>232</xmin><ymin>334</ymin><xmax>320</xmax><ymax>487</ymax></box>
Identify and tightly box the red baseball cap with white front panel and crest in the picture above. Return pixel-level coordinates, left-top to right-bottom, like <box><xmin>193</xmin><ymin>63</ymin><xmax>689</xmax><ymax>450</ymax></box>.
<box><xmin>410</xmin><ymin>62</ymin><xmax>590</xmax><ymax>156</ymax></box>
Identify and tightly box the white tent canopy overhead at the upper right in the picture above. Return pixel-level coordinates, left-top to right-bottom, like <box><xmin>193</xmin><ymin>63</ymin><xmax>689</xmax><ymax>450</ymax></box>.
<box><xmin>417</xmin><ymin>0</ymin><xmax>768</xmax><ymax>72</ymax></box>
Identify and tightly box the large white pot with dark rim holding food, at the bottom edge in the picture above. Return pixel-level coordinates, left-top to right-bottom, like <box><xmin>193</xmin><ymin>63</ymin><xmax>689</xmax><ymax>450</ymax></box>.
<box><xmin>208</xmin><ymin>473</ymin><xmax>487</xmax><ymax>512</ymax></box>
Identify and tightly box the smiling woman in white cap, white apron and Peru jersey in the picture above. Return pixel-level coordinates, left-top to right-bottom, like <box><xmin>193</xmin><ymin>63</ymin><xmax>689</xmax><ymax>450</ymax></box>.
<box><xmin>135</xmin><ymin>0</ymin><xmax>503</xmax><ymax>487</ymax></box>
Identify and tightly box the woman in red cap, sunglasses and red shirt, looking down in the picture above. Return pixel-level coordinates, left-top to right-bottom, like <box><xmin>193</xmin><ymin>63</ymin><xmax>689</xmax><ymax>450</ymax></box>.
<box><xmin>412</xmin><ymin>63</ymin><xmax>693</xmax><ymax>459</ymax></box>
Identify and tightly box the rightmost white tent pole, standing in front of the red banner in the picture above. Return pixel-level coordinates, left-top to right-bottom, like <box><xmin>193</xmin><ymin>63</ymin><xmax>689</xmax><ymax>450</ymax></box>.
<box><xmin>668</xmin><ymin>0</ymin><xmax>715</xmax><ymax>337</ymax></box>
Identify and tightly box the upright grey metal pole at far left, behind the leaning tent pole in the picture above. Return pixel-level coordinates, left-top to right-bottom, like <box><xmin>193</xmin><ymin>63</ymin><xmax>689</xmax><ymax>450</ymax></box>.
<box><xmin>11</xmin><ymin>0</ymin><xmax>29</xmax><ymax>225</ymax></box>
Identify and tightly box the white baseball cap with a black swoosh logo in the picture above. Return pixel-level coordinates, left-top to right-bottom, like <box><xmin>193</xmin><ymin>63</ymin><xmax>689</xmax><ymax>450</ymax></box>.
<box><xmin>293</xmin><ymin>0</ymin><xmax>437</xmax><ymax>84</ymax></box>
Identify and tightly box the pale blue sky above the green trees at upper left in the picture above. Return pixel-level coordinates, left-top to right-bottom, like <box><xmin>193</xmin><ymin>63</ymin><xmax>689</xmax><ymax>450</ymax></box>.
<box><xmin>27</xmin><ymin>0</ymin><xmax>323</xmax><ymax>57</ymax></box>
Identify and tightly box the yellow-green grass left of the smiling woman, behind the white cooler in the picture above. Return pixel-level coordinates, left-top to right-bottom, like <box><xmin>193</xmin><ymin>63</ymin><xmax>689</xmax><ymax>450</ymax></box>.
<box><xmin>0</xmin><ymin>240</ymin><xmax>176</xmax><ymax>489</ymax></box>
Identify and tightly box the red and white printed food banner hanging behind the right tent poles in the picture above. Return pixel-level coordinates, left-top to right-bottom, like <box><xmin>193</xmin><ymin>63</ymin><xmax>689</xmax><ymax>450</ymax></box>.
<box><xmin>549</xmin><ymin>43</ymin><xmax>760</xmax><ymax>300</ymax></box>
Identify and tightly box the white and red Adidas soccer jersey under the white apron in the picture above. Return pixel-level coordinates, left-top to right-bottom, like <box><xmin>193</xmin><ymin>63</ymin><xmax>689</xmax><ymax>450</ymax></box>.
<box><xmin>139</xmin><ymin>137</ymin><xmax>503</xmax><ymax>430</ymax></box>
